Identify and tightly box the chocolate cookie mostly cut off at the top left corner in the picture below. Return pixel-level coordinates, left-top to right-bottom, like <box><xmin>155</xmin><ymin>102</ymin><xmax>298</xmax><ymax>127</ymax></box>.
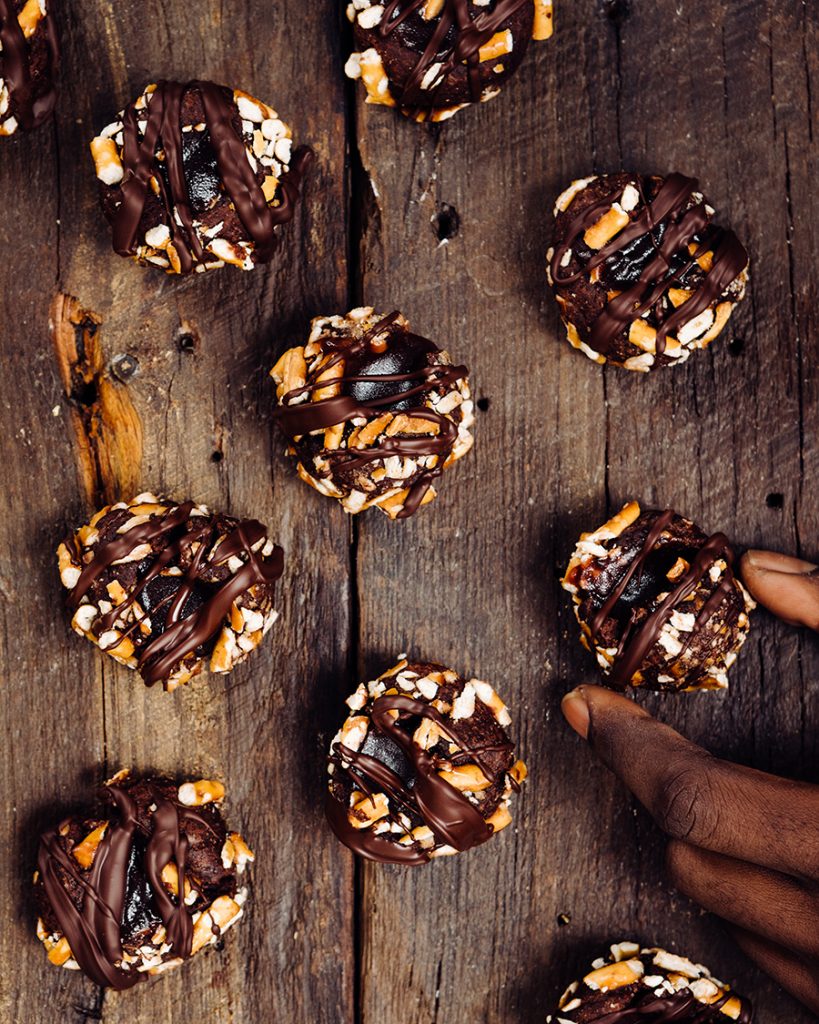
<box><xmin>0</xmin><ymin>0</ymin><xmax>59</xmax><ymax>136</ymax></box>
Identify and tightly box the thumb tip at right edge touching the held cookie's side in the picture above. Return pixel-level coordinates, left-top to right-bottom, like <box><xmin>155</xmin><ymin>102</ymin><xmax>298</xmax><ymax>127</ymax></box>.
<box><xmin>740</xmin><ymin>551</ymin><xmax>819</xmax><ymax>630</ymax></box>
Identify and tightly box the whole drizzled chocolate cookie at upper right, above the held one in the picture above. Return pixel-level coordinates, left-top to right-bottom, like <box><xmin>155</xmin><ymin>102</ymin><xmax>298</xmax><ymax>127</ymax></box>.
<box><xmin>549</xmin><ymin>171</ymin><xmax>748</xmax><ymax>372</ymax></box>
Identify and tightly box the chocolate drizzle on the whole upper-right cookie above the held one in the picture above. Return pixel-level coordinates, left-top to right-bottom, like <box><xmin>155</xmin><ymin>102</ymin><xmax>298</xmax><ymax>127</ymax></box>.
<box><xmin>550</xmin><ymin>174</ymin><xmax>748</xmax><ymax>355</ymax></box>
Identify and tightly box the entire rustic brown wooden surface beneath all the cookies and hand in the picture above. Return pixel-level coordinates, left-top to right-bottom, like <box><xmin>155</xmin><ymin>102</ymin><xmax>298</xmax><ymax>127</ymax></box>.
<box><xmin>0</xmin><ymin>0</ymin><xmax>819</xmax><ymax>1024</ymax></box>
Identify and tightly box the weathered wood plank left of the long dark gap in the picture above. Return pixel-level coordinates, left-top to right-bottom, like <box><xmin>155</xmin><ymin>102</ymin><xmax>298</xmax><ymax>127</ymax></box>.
<box><xmin>0</xmin><ymin>0</ymin><xmax>354</xmax><ymax>1024</ymax></box>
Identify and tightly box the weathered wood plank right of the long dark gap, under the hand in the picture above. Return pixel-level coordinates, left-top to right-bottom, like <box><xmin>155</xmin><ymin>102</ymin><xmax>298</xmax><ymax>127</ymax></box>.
<box><xmin>358</xmin><ymin>0</ymin><xmax>819</xmax><ymax>1024</ymax></box>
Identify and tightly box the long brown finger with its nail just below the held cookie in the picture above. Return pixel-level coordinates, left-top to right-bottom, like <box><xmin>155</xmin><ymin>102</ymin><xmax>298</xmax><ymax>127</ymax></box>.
<box><xmin>563</xmin><ymin>686</ymin><xmax>819</xmax><ymax>879</ymax></box>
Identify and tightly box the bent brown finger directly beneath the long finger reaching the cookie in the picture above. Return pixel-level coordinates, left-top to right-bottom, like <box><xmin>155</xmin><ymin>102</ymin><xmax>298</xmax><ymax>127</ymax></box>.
<box><xmin>666</xmin><ymin>841</ymin><xmax>819</xmax><ymax>959</ymax></box>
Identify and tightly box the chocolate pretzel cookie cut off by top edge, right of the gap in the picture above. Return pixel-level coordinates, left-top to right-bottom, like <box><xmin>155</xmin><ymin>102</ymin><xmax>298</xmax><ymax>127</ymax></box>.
<box><xmin>345</xmin><ymin>0</ymin><xmax>552</xmax><ymax>121</ymax></box>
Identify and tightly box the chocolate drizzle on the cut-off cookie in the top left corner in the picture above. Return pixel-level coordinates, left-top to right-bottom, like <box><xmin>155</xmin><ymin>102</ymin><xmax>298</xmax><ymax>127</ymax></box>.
<box><xmin>0</xmin><ymin>0</ymin><xmax>59</xmax><ymax>131</ymax></box>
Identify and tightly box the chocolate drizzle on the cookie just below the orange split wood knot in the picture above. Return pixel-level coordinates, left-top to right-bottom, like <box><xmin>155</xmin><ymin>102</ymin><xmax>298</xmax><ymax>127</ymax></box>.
<box><xmin>70</xmin><ymin>502</ymin><xmax>284</xmax><ymax>686</ymax></box>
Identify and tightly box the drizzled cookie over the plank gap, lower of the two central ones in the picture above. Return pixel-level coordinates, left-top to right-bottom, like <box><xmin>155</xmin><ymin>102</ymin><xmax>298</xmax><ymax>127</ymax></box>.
<box><xmin>327</xmin><ymin>660</ymin><xmax>526</xmax><ymax>864</ymax></box>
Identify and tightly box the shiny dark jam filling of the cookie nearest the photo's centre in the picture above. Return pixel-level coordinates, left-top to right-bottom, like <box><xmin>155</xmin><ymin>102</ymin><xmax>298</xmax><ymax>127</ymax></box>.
<box><xmin>344</xmin><ymin>334</ymin><xmax>435</xmax><ymax>414</ymax></box>
